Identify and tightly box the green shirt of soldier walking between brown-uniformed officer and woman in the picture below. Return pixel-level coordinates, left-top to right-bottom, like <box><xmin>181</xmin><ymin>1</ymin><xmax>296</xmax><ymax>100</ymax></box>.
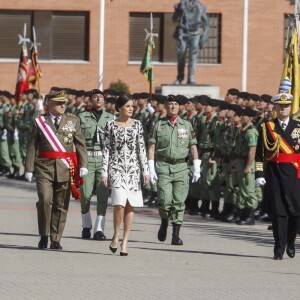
<box><xmin>78</xmin><ymin>110</ymin><xmax>114</xmax><ymax>151</ymax></box>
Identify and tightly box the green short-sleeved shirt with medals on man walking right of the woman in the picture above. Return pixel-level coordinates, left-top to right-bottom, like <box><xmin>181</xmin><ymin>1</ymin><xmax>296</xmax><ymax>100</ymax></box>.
<box><xmin>149</xmin><ymin>117</ymin><xmax>197</xmax><ymax>174</ymax></box>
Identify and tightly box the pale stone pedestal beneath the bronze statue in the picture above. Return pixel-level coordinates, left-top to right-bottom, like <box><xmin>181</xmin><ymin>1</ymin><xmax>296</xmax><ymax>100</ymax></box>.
<box><xmin>161</xmin><ymin>84</ymin><xmax>220</xmax><ymax>99</ymax></box>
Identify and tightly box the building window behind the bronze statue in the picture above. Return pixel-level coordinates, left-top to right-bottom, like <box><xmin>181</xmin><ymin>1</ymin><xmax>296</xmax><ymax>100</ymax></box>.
<box><xmin>129</xmin><ymin>13</ymin><xmax>221</xmax><ymax>64</ymax></box>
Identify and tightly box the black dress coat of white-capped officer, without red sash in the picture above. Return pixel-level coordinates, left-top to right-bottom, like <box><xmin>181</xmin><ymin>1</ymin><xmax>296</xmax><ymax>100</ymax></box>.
<box><xmin>255</xmin><ymin>118</ymin><xmax>300</xmax><ymax>216</ymax></box>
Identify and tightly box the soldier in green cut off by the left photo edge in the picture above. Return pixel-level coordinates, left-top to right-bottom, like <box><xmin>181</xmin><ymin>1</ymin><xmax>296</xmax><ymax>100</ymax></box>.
<box><xmin>0</xmin><ymin>91</ymin><xmax>12</xmax><ymax>176</ymax></box>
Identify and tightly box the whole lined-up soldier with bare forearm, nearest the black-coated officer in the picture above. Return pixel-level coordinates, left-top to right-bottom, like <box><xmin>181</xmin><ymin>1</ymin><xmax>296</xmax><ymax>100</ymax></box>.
<box><xmin>235</xmin><ymin>108</ymin><xmax>258</xmax><ymax>225</ymax></box>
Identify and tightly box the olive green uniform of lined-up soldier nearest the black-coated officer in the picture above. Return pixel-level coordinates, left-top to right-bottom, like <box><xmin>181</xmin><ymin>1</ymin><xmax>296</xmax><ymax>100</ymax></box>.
<box><xmin>235</xmin><ymin>123</ymin><xmax>258</xmax><ymax>210</ymax></box>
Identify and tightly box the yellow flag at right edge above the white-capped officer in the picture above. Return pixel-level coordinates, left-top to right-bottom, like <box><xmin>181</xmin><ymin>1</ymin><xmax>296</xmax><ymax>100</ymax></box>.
<box><xmin>279</xmin><ymin>18</ymin><xmax>300</xmax><ymax>115</ymax></box>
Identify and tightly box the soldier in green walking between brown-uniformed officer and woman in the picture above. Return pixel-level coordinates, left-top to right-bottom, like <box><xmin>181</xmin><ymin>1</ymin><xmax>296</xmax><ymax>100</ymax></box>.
<box><xmin>78</xmin><ymin>89</ymin><xmax>114</xmax><ymax>240</ymax></box>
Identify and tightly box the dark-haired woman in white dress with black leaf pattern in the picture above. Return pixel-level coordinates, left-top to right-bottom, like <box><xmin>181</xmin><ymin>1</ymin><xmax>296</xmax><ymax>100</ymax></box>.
<box><xmin>101</xmin><ymin>94</ymin><xmax>149</xmax><ymax>256</ymax></box>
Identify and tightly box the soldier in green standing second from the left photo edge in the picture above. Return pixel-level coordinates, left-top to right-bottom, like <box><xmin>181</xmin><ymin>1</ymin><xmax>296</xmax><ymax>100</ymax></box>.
<box><xmin>4</xmin><ymin>93</ymin><xmax>22</xmax><ymax>178</ymax></box>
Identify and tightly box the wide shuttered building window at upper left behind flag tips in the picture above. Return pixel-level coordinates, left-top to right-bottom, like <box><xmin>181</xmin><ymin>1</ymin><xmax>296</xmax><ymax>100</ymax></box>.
<box><xmin>0</xmin><ymin>10</ymin><xmax>89</xmax><ymax>61</ymax></box>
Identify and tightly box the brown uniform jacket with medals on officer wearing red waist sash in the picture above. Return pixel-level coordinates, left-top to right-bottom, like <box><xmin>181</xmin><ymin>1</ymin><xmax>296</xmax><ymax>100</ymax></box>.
<box><xmin>25</xmin><ymin>113</ymin><xmax>87</xmax><ymax>182</ymax></box>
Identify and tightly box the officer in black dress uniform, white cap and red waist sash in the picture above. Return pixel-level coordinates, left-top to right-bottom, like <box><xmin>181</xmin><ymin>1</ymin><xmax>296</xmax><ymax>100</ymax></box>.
<box><xmin>256</xmin><ymin>93</ymin><xmax>300</xmax><ymax>260</ymax></box>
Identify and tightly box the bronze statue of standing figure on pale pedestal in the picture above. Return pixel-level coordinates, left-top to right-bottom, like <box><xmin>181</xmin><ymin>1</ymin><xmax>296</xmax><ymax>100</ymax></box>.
<box><xmin>173</xmin><ymin>0</ymin><xmax>209</xmax><ymax>84</ymax></box>
